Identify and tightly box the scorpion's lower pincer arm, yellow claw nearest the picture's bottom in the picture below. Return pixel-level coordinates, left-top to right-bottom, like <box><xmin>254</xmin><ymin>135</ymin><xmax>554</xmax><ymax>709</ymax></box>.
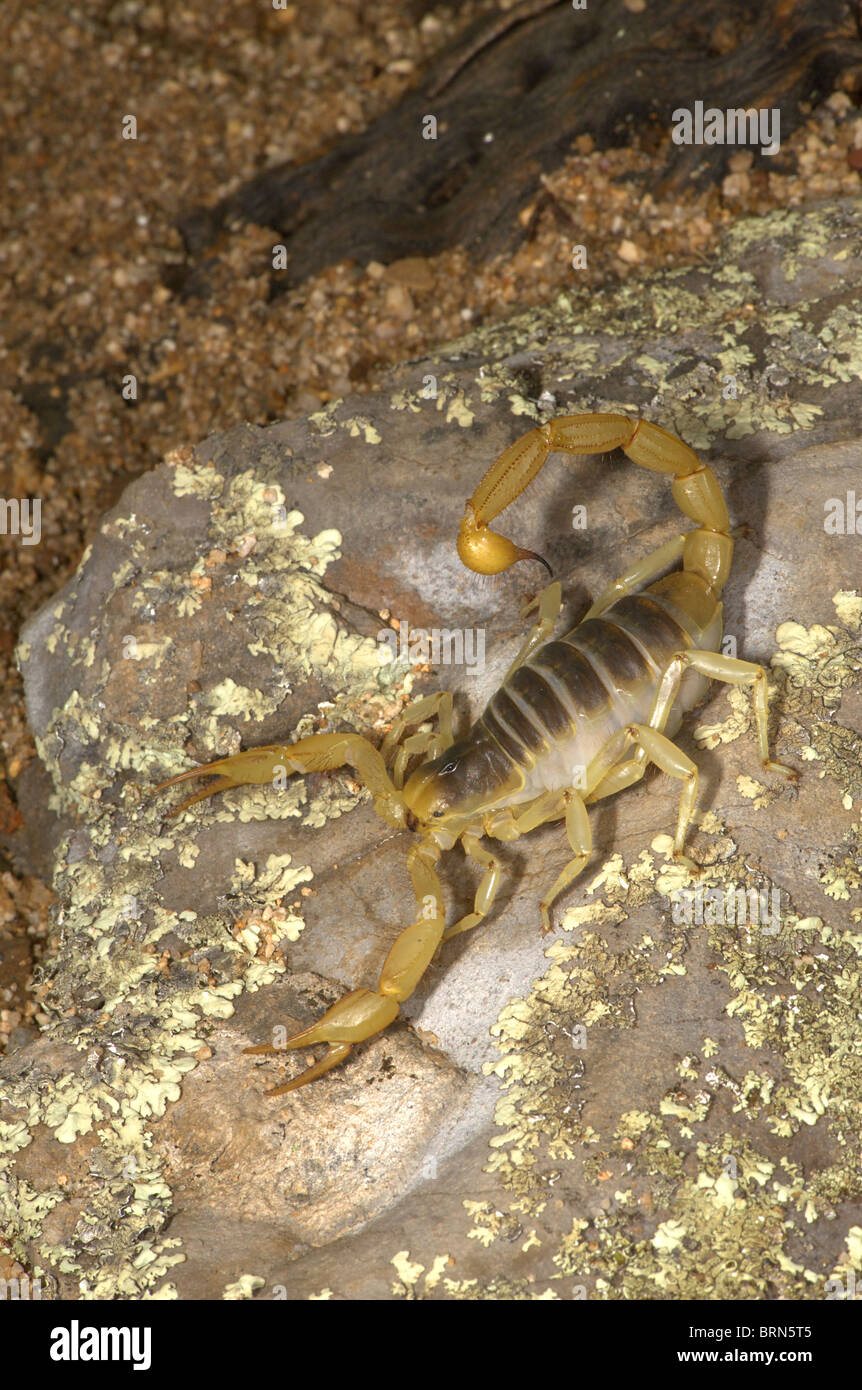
<box><xmin>246</xmin><ymin>841</ymin><xmax>445</xmax><ymax>1095</ymax></box>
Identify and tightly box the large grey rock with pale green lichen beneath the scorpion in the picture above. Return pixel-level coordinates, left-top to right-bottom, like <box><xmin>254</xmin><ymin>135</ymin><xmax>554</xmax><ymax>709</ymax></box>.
<box><xmin>0</xmin><ymin>203</ymin><xmax>862</xmax><ymax>1300</ymax></box>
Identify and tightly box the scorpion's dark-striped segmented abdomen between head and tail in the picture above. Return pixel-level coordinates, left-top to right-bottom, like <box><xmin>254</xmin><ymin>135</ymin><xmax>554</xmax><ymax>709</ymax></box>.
<box><xmin>480</xmin><ymin>592</ymin><xmax>720</xmax><ymax>801</ymax></box>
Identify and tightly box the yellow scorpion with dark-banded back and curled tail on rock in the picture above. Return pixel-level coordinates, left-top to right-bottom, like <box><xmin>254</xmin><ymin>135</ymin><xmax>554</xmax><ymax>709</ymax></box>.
<box><xmin>157</xmin><ymin>414</ymin><xmax>798</xmax><ymax>1095</ymax></box>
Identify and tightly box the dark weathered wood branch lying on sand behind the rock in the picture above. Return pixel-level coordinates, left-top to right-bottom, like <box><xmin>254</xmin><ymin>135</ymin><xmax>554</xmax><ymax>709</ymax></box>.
<box><xmin>179</xmin><ymin>0</ymin><xmax>862</xmax><ymax>292</ymax></box>
